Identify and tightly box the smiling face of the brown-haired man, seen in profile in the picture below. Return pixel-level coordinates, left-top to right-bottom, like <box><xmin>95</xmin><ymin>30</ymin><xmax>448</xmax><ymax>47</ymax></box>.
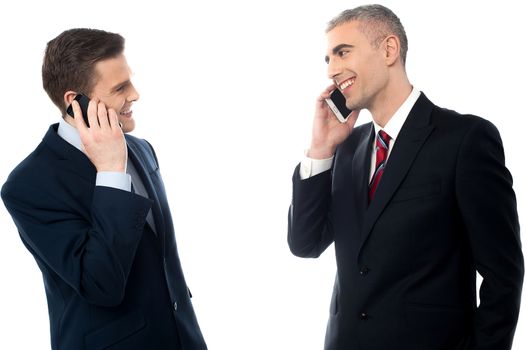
<box><xmin>90</xmin><ymin>54</ymin><xmax>139</xmax><ymax>132</ymax></box>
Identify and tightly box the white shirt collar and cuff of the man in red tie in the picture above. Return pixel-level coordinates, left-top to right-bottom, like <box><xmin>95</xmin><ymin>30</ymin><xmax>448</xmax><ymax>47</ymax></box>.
<box><xmin>300</xmin><ymin>88</ymin><xmax>420</xmax><ymax>180</ymax></box>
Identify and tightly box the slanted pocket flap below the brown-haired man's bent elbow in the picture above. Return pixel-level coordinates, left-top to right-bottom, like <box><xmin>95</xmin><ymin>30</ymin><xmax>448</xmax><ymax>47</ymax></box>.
<box><xmin>84</xmin><ymin>310</ymin><xmax>146</xmax><ymax>350</ymax></box>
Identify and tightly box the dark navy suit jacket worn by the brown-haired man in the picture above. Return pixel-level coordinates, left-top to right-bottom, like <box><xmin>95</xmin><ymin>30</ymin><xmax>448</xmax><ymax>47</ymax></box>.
<box><xmin>2</xmin><ymin>124</ymin><xmax>206</xmax><ymax>350</ymax></box>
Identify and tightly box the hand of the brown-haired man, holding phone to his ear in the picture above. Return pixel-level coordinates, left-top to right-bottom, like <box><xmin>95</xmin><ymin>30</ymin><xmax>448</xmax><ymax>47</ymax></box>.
<box><xmin>72</xmin><ymin>99</ymin><xmax>128</xmax><ymax>172</ymax></box>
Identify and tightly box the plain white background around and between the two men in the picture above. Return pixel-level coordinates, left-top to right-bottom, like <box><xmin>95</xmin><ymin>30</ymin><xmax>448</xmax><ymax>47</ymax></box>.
<box><xmin>0</xmin><ymin>0</ymin><xmax>526</xmax><ymax>350</ymax></box>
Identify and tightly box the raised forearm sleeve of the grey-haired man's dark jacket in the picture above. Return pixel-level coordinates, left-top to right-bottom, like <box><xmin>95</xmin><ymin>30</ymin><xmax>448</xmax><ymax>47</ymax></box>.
<box><xmin>287</xmin><ymin>165</ymin><xmax>334</xmax><ymax>258</ymax></box>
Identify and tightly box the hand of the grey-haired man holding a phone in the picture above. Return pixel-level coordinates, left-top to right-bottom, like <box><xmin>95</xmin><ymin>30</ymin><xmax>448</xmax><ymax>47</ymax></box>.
<box><xmin>307</xmin><ymin>84</ymin><xmax>360</xmax><ymax>159</ymax></box>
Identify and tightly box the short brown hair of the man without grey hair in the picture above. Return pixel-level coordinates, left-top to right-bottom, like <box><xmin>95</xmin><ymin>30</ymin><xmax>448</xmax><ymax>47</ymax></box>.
<box><xmin>42</xmin><ymin>28</ymin><xmax>124</xmax><ymax>115</ymax></box>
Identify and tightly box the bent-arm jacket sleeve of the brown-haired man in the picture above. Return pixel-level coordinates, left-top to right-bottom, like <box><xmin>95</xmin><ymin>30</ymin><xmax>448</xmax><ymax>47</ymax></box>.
<box><xmin>2</xmin><ymin>183</ymin><xmax>152</xmax><ymax>306</ymax></box>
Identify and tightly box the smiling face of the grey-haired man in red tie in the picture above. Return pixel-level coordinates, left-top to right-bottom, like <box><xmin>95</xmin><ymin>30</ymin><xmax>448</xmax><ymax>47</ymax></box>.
<box><xmin>325</xmin><ymin>21</ymin><xmax>388</xmax><ymax>110</ymax></box>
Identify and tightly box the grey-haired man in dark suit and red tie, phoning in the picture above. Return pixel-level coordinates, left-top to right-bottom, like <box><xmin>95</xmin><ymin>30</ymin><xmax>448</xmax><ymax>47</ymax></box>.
<box><xmin>288</xmin><ymin>5</ymin><xmax>524</xmax><ymax>350</ymax></box>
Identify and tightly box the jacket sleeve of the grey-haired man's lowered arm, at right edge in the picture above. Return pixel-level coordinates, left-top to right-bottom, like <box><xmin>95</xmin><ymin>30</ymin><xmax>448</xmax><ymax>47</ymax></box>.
<box><xmin>456</xmin><ymin>120</ymin><xmax>524</xmax><ymax>350</ymax></box>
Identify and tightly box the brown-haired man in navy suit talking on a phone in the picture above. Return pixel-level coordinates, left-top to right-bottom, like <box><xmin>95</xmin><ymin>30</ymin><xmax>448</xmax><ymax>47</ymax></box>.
<box><xmin>2</xmin><ymin>29</ymin><xmax>207</xmax><ymax>350</ymax></box>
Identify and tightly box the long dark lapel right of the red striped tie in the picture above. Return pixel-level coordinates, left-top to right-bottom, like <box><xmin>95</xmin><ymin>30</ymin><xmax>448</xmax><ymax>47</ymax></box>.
<box><xmin>360</xmin><ymin>93</ymin><xmax>434</xmax><ymax>251</ymax></box>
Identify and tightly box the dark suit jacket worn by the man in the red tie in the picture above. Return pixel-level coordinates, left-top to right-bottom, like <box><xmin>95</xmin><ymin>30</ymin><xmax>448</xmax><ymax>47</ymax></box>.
<box><xmin>288</xmin><ymin>94</ymin><xmax>524</xmax><ymax>350</ymax></box>
